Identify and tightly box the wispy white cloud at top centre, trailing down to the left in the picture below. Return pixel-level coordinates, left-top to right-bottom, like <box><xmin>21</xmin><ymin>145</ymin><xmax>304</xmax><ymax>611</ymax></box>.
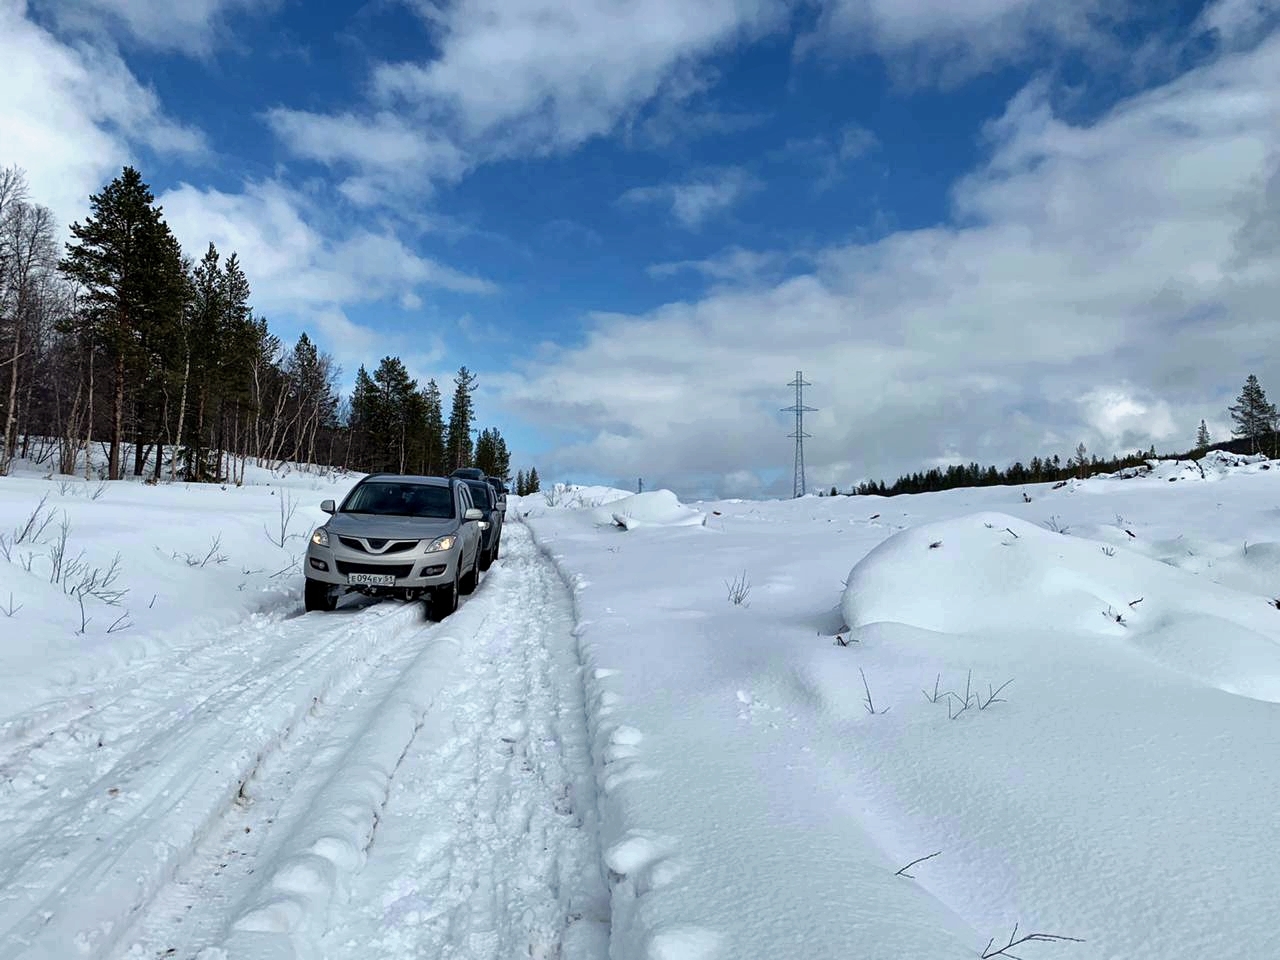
<box><xmin>268</xmin><ymin>0</ymin><xmax>790</xmax><ymax>205</ymax></box>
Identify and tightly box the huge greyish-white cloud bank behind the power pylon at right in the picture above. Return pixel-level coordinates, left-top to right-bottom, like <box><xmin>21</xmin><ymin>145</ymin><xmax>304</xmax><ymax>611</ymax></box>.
<box><xmin>503</xmin><ymin>35</ymin><xmax>1280</xmax><ymax>496</ymax></box>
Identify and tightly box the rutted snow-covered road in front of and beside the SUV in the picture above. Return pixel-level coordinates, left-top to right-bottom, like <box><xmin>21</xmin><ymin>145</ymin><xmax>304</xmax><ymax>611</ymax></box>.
<box><xmin>0</xmin><ymin>524</ymin><xmax>609</xmax><ymax>960</ymax></box>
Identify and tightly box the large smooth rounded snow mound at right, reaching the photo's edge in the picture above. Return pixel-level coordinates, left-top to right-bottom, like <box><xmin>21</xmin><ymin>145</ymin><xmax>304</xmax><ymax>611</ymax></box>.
<box><xmin>841</xmin><ymin>513</ymin><xmax>1280</xmax><ymax>701</ymax></box>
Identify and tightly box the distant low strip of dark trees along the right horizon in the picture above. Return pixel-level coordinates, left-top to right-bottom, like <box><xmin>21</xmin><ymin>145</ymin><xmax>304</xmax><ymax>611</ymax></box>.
<box><xmin>829</xmin><ymin>374</ymin><xmax>1280</xmax><ymax>497</ymax></box>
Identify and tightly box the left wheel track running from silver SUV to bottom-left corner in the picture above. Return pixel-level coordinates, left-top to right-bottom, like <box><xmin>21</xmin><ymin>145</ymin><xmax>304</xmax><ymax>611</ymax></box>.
<box><xmin>0</xmin><ymin>605</ymin><xmax>432</xmax><ymax>957</ymax></box>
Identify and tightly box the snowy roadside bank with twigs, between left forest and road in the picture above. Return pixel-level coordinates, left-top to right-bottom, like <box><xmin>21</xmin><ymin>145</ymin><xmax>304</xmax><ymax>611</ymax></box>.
<box><xmin>0</xmin><ymin>471</ymin><xmax>358</xmax><ymax>727</ymax></box>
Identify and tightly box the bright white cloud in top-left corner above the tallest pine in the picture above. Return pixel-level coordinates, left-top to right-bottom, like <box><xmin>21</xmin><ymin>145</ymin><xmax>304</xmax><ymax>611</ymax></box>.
<box><xmin>0</xmin><ymin>0</ymin><xmax>205</xmax><ymax>221</ymax></box>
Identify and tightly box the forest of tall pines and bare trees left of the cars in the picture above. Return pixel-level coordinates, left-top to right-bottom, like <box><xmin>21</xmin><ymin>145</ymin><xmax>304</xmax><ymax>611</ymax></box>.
<box><xmin>0</xmin><ymin>166</ymin><xmax>511</xmax><ymax>483</ymax></box>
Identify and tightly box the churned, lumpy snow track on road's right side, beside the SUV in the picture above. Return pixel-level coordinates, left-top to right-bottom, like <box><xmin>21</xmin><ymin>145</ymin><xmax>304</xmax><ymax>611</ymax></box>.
<box><xmin>304</xmin><ymin>524</ymin><xmax>609</xmax><ymax>960</ymax></box>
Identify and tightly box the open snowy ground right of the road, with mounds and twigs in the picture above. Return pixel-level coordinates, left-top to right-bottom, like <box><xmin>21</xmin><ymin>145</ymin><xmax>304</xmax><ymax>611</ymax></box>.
<box><xmin>530</xmin><ymin>471</ymin><xmax>1280</xmax><ymax>960</ymax></box>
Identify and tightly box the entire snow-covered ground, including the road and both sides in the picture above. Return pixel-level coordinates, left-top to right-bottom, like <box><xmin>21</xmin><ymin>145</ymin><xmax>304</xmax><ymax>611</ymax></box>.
<box><xmin>0</xmin><ymin>454</ymin><xmax>1280</xmax><ymax>960</ymax></box>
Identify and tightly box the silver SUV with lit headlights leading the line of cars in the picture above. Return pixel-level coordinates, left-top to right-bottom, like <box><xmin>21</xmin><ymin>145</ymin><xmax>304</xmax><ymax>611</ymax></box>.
<box><xmin>305</xmin><ymin>474</ymin><xmax>488</xmax><ymax>620</ymax></box>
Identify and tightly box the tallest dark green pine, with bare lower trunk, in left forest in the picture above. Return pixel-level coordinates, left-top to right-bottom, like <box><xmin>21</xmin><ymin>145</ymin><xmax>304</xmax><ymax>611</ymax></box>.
<box><xmin>59</xmin><ymin>166</ymin><xmax>180</xmax><ymax>480</ymax></box>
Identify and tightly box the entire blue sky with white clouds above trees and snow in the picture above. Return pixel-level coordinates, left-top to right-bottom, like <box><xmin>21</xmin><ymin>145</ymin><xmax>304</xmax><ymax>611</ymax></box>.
<box><xmin>0</xmin><ymin>0</ymin><xmax>1280</xmax><ymax>495</ymax></box>
